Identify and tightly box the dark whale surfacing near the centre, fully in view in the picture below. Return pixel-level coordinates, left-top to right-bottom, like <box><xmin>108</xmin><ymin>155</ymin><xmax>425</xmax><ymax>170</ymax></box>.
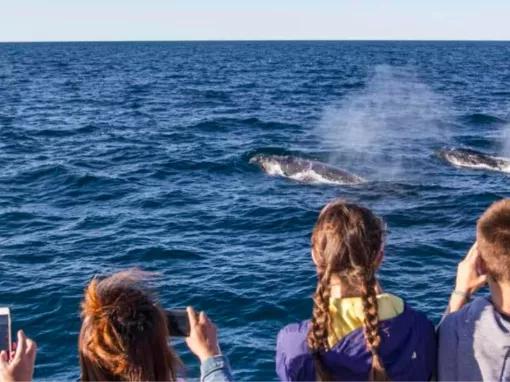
<box><xmin>249</xmin><ymin>154</ymin><xmax>365</xmax><ymax>185</ymax></box>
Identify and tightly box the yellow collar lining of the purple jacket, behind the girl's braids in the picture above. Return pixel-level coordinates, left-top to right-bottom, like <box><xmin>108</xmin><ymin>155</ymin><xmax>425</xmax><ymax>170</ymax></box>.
<box><xmin>328</xmin><ymin>293</ymin><xmax>404</xmax><ymax>347</ymax></box>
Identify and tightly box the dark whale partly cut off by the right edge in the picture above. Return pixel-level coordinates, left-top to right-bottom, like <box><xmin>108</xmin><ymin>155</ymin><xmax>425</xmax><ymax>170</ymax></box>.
<box><xmin>438</xmin><ymin>148</ymin><xmax>510</xmax><ymax>172</ymax></box>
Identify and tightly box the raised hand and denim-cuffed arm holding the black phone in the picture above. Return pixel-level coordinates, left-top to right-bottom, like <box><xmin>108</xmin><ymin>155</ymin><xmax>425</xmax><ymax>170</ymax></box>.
<box><xmin>186</xmin><ymin>307</ymin><xmax>233</xmax><ymax>382</ymax></box>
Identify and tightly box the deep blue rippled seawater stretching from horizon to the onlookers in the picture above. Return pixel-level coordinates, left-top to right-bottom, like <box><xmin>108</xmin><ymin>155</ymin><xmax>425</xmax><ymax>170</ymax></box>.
<box><xmin>0</xmin><ymin>42</ymin><xmax>510</xmax><ymax>380</ymax></box>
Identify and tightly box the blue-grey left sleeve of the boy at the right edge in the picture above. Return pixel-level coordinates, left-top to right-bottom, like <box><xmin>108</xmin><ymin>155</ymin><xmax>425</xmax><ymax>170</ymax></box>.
<box><xmin>437</xmin><ymin>315</ymin><xmax>459</xmax><ymax>381</ymax></box>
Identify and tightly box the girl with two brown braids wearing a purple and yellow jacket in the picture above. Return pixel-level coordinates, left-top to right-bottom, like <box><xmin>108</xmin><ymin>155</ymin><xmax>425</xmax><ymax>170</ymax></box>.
<box><xmin>276</xmin><ymin>200</ymin><xmax>436</xmax><ymax>381</ymax></box>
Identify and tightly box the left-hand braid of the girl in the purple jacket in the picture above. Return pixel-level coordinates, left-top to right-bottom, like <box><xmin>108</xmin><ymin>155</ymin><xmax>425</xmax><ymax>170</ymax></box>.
<box><xmin>307</xmin><ymin>266</ymin><xmax>331</xmax><ymax>381</ymax></box>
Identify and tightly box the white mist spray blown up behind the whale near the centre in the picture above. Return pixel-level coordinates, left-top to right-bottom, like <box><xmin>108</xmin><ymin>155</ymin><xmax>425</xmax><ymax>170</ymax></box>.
<box><xmin>316</xmin><ymin>65</ymin><xmax>449</xmax><ymax>179</ymax></box>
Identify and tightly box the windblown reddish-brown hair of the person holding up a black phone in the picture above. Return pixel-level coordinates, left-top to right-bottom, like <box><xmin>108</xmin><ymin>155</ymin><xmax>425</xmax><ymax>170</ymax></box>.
<box><xmin>79</xmin><ymin>271</ymin><xmax>181</xmax><ymax>381</ymax></box>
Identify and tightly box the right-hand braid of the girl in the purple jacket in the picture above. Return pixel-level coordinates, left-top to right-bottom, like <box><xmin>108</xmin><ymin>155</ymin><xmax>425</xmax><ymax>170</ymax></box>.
<box><xmin>361</xmin><ymin>270</ymin><xmax>389</xmax><ymax>381</ymax></box>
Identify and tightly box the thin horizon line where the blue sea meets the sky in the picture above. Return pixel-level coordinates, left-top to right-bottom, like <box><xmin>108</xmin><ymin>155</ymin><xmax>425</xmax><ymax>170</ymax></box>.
<box><xmin>0</xmin><ymin>38</ymin><xmax>510</xmax><ymax>44</ymax></box>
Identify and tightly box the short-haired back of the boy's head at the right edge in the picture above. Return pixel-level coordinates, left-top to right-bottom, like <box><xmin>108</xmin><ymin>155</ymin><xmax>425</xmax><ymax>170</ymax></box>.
<box><xmin>477</xmin><ymin>199</ymin><xmax>510</xmax><ymax>282</ymax></box>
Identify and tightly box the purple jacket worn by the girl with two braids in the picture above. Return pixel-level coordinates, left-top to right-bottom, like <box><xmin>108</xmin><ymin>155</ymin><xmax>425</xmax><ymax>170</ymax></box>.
<box><xmin>276</xmin><ymin>304</ymin><xmax>436</xmax><ymax>381</ymax></box>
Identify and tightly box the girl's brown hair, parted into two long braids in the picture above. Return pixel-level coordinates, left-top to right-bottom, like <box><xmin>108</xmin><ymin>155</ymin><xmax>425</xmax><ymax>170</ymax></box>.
<box><xmin>307</xmin><ymin>200</ymin><xmax>389</xmax><ymax>381</ymax></box>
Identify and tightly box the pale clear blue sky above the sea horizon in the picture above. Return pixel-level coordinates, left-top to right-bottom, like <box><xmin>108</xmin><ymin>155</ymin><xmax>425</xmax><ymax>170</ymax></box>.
<box><xmin>0</xmin><ymin>0</ymin><xmax>510</xmax><ymax>41</ymax></box>
